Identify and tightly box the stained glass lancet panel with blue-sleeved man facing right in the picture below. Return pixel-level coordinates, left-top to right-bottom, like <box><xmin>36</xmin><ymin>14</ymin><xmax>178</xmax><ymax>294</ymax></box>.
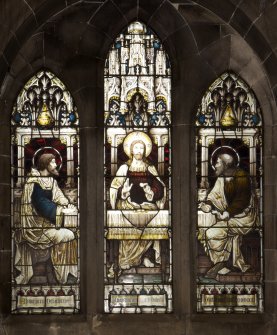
<box><xmin>11</xmin><ymin>70</ymin><xmax>80</xmax><ymax>314</ymax></box>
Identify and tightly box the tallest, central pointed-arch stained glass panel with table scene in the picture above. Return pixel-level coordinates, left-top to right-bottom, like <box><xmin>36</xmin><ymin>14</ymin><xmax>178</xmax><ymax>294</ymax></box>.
<box><xmin>104</xmin><ymin>22</ymin><xmax>172</xmax><ymax>313</ymax></box>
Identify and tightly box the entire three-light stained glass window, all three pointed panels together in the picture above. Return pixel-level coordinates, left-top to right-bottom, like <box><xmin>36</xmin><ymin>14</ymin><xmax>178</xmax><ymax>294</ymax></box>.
<box><xmin>11</xmin><ymin>28</ymin><xmax>263</xmax><ymax>314</ymax></box>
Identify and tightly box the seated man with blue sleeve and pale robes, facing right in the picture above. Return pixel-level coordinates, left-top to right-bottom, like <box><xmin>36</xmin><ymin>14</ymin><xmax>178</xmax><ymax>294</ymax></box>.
<box><xmin>15</xmin><ymin>154</ymin><xmax>78</xmax><ymax>284</ymax></box>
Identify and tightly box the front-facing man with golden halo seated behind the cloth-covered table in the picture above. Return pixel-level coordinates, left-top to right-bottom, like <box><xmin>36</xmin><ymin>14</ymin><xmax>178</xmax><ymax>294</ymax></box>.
<box><xmin>110</xmin><ymin>131</ymin><xmax>166</xmax><ymax>276</ymax></box>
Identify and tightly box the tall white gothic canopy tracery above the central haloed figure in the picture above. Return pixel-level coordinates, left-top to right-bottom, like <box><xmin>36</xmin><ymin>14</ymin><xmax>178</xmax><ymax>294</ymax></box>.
<box><xmin>105</xmin><ymin>22</ymin><xmax>171</xmax><ymax>127</ymax></box>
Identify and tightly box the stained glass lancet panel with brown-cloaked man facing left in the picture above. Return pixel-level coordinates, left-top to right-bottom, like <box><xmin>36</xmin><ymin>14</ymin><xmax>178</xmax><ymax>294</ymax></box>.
<box><xmin>196</xmin><ymin>73</ymin><xmax>263</xmax><ymax>313</ymax></box>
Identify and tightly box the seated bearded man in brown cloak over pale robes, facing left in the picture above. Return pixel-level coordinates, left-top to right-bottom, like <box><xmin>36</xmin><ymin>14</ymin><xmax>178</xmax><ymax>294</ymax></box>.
<box><xmin>198</xmin><ymin>154</ymin><xmax>258</xmax><ymax>279</ymax></box>
